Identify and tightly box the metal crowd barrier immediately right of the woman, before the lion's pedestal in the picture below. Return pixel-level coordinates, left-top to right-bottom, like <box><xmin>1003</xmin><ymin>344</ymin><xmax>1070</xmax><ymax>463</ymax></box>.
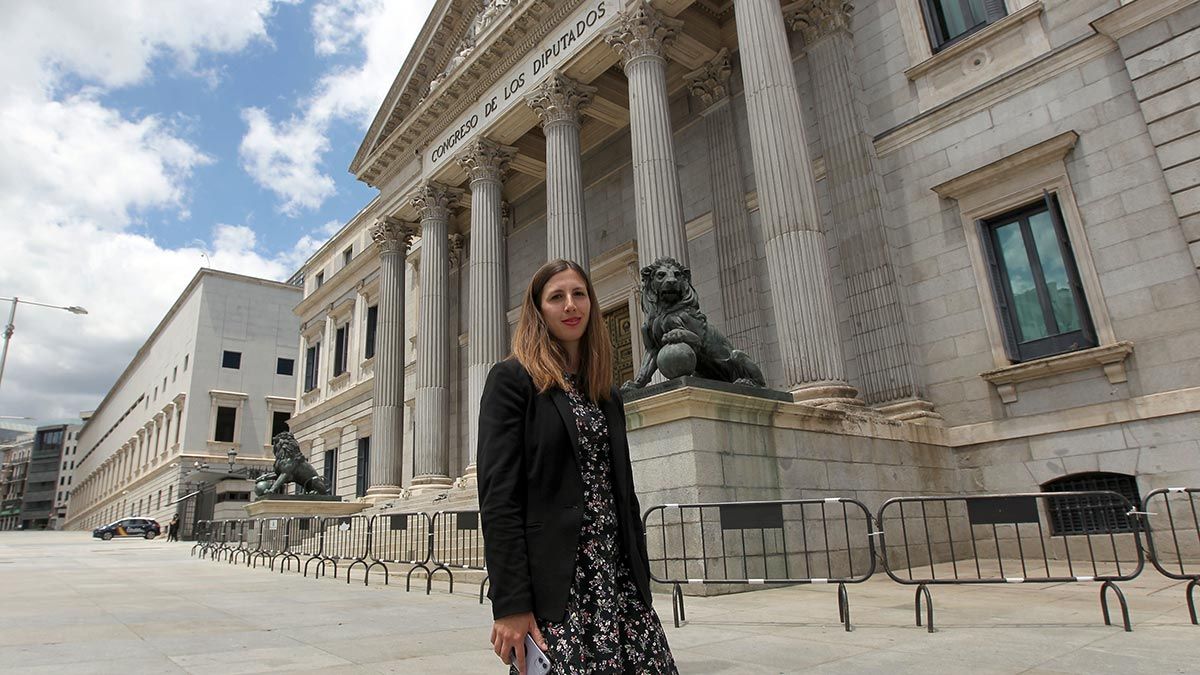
<box><xmin>642</xmin><ymin>497</ymin><xmax>875</xmax><ymax>631</ymax></box>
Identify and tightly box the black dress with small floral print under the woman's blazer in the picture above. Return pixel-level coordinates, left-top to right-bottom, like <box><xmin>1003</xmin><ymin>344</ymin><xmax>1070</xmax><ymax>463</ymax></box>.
<box><xmin>511</xmin><ymin>375</ymin><xmax>678</xmax><ymax>675</ymax></box>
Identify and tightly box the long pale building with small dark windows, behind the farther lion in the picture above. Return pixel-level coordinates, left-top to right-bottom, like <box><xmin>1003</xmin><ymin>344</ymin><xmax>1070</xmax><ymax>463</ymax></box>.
<box><xmin>65</xmin><ymin>269</ymin><xmax>301</xmax><ymax>536</ymax></box>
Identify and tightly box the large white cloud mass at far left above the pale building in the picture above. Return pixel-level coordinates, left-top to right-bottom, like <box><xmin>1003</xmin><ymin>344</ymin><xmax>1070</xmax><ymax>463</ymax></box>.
<box><xmin>0</xmin><ymin>0</ymin><xmax>311</xmax><ymax>417</ymax></box>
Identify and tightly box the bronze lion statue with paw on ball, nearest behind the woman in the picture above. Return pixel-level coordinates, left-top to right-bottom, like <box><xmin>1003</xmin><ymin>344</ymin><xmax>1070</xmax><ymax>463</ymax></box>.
<box><xmin>622</xmin><ymin>257</ymin><xmax>767</xmax><ymax>392</ymax></box>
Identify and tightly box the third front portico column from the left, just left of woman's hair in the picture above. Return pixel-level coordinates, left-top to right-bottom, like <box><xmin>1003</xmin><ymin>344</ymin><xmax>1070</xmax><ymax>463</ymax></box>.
<box><xmin>458</xmin><ymin>139</ymin><xmax>511</xmax><ymax>478</ymax></box>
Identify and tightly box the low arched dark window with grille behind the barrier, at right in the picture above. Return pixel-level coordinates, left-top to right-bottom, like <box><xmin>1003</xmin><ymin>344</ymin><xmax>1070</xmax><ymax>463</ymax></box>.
<box><xmin>1042</xmin><ymin>471</ymin><xmax>1141</xmax><ymax>536</ymax></box>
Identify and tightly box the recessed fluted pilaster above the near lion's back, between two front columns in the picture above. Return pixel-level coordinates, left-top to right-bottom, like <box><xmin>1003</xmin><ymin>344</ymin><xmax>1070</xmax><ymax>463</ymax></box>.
<box><xmin>684</xmin><ymin>49</ymin><xmax>762</xmax><ymax>363</ymax></box>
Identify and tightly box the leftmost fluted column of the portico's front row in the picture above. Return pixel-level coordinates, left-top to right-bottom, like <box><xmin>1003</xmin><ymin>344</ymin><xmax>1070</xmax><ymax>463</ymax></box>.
<box><xmin>364</xmin><ymin>216</ymin><xmax>416</xmax><ymax>501</ymax></box>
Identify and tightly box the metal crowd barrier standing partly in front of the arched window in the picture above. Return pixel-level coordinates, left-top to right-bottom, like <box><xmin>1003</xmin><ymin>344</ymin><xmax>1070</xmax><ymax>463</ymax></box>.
<box><xmin>877</xmin><ymin>490</ymin><xmax>1145</xmax><ymax>633</ymax></box>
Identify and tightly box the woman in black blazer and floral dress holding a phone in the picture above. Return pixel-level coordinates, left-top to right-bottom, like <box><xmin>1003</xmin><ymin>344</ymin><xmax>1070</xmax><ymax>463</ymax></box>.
<box><xmin>478</xmin><ymin>259</ymin><xmax>676</xmax><ymax>673</ymax></box>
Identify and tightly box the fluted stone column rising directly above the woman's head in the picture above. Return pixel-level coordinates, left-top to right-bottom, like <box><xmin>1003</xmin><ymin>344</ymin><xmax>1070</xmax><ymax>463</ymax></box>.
<box><xmin>528</xmin><ymin>72</ymin><xmax>595</xmax><ymax>269</ymax></box>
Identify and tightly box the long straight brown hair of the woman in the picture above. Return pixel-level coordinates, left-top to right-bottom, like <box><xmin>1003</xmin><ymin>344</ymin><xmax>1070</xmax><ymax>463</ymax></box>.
<box><xmin>512</xmin><ymin>258</ymin><xmax>612</xmax><ymax>401</ymax></box>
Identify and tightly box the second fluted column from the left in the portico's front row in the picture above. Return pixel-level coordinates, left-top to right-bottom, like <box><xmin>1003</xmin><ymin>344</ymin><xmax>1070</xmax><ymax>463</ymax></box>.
<box><xmin>413</xmin><ymin>183</ymin><xmax>462</xmax><ymax>488</ymax></box>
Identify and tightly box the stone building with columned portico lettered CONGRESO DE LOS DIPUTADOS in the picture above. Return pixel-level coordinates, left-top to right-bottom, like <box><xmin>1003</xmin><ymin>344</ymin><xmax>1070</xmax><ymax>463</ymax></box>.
<box><xmin>296</xmin><ymin>0</ymin><xmax>1200</xmax><ymax>501</ymax></box>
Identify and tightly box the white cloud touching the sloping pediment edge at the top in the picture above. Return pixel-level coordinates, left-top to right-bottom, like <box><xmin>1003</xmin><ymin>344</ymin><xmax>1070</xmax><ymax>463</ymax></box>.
<box><xmin>241</xmin><ymin>0</ymin><xmax>433</xmax><ymax>210</ymax></box>
